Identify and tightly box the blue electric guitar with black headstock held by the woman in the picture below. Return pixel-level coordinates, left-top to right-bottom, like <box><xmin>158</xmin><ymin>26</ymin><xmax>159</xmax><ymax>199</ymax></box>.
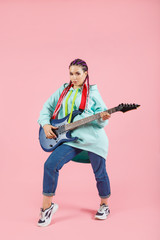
<box><xmin>39</xmin><ymin>103</ymin><xmax>140</xmax><ymax>152</ymax></box>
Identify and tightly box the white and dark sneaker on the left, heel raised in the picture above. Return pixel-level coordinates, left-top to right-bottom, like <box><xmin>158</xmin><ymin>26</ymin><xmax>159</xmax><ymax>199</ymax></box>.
<box><xmin>37</xmin><ymin>203</ymin><xmax>58</xmax><ymax>227</ymax></box>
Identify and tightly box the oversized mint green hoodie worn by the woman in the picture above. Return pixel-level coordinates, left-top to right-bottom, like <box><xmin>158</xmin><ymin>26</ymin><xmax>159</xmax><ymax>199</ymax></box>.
<box><xmin>37</xmin><ymin>83</ymin><xmax>109</xmax><ymax>163</ymax></box>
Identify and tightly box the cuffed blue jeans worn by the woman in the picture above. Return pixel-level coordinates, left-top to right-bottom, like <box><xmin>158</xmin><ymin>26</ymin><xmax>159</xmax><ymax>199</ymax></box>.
<box><xmin>42</xmin><ymin>144</ymin><xmax>111</xmax><ymax>198</ymax></box>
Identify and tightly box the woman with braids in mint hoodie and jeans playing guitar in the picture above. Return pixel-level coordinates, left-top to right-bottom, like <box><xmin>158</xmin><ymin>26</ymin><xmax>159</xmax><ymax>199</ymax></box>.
<box><xmin>38</xmin><ymin>59</ymin><xmax>111</xmax><ymax>226</ymax></box>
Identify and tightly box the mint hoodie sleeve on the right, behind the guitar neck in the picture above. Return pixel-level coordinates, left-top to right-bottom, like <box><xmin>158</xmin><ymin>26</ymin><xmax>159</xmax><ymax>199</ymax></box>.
<box><xmin>74</xmin><ymin>90</ymin><xmax>109</xmax><ymax>128</ymax></box>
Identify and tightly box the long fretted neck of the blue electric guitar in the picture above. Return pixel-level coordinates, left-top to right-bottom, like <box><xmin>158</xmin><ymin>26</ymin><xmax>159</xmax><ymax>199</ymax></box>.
<box><xmin>65</xmin><ymin>107</ymin><xmax>117</xmax><ymax>131</ymax></box>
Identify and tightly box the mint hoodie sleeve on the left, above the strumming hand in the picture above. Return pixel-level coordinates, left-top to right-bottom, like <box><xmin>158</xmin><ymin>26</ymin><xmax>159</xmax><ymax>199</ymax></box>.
<box><xmin>37</xmin><ymin>83</ymin><xmax>66</xmax><ymax>127</ymax></box>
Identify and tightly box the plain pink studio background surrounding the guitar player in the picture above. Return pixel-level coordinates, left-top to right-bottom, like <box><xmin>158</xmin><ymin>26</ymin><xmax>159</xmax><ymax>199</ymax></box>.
<box><xmin>0</xmin><ymin>0</ymin><xmax>160</xmax><ymax>240</ymax></box>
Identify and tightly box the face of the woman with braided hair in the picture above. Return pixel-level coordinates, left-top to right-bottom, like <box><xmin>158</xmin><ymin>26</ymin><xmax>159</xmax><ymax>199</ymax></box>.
<box><xmin>69</xmin><ymin>65</ymin><xmax>87</xmax><ymax>88</ymax></box>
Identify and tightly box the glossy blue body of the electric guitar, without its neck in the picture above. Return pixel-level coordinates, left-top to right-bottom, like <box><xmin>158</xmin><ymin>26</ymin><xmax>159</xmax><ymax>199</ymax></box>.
<box><xmin>39</xmin><ymin>110</ymin><xmax>82</xmax><ymax>152</ymax></box>
